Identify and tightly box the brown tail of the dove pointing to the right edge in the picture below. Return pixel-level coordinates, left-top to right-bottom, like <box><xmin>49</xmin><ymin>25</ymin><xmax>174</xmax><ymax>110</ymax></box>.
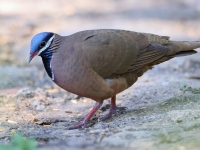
<box><xmin>167</xmin><ymin>41</ymin><xmax>200</xmax><ymax>57</ymax></box>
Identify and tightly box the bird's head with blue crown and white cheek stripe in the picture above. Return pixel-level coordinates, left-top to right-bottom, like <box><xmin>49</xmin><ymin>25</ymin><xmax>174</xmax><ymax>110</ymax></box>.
<box><xmin>29</xmin><ymin>32</ymin><xmax>54</xmax><ymax>63</ymax></box>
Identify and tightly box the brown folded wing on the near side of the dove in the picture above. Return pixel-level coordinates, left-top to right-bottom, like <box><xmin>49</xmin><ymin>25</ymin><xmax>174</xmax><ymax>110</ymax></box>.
<box><xmin>74</xmin><ymin>30</ymin><xmax>169</xmax><ymax>78</ymax></box>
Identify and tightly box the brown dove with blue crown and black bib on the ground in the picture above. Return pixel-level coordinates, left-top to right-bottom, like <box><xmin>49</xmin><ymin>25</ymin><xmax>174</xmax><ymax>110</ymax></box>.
<box><xmin>28</xmin><ymin>29</ymin><xmax>200</xmax><ymax>129</ymax></box>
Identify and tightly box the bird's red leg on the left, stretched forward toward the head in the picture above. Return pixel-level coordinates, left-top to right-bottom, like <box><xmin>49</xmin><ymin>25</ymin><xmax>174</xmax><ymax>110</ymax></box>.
<box><xmin>69</xmin><ymin>102</ymin><xmax>102</xmax><ymax>129</ymax></box>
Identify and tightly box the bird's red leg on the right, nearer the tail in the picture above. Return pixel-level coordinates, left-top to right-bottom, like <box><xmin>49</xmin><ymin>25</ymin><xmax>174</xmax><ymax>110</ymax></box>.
<box><xmin>101</xmin><ymin>96</ymin><xmax>117</xmax><ymax>121</ymax></box>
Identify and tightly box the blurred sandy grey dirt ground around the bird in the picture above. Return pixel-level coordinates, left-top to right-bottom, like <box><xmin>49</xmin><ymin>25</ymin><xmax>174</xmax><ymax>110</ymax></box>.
<box><xmin>0</xmin><ymin>0</ymin><xmax>200</xmax><ymax>150</ymax></box>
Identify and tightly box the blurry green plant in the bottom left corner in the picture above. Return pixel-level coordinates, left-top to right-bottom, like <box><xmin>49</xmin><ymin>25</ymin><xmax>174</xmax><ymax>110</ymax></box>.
<box><xmin>0</xmin><ymin>133</ymin><xmax>36</xmax><ymax>150</ymax></box>
